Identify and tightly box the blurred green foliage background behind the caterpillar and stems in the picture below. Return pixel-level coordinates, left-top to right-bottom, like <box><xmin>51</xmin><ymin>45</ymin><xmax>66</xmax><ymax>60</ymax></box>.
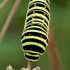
<box><xmin>0</xmin><ymin>0</ymin><xmax>70</xmax><ymax>70</ymax></box>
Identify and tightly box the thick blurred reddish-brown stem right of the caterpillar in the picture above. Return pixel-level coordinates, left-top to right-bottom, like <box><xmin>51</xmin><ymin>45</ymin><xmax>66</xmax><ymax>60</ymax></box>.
<box><xmin>48</xmin><ymin>23</ymin><xmax>61</xmax><ymax>70</ymax></box>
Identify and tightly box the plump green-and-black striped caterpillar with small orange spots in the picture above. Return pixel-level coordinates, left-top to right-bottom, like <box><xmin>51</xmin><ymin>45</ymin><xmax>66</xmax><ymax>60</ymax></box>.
<box><xmin>21</xmin><ymin>0</ymin><xmax>50</xmax><ymax>61</ymax></box>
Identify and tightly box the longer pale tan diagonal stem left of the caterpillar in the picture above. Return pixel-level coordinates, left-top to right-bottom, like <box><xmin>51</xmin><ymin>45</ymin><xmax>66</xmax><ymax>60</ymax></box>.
<box><xmin>0</xmin><ymin>0</ymin><xmax>21</xmax><ymax>42</ymax></box>
